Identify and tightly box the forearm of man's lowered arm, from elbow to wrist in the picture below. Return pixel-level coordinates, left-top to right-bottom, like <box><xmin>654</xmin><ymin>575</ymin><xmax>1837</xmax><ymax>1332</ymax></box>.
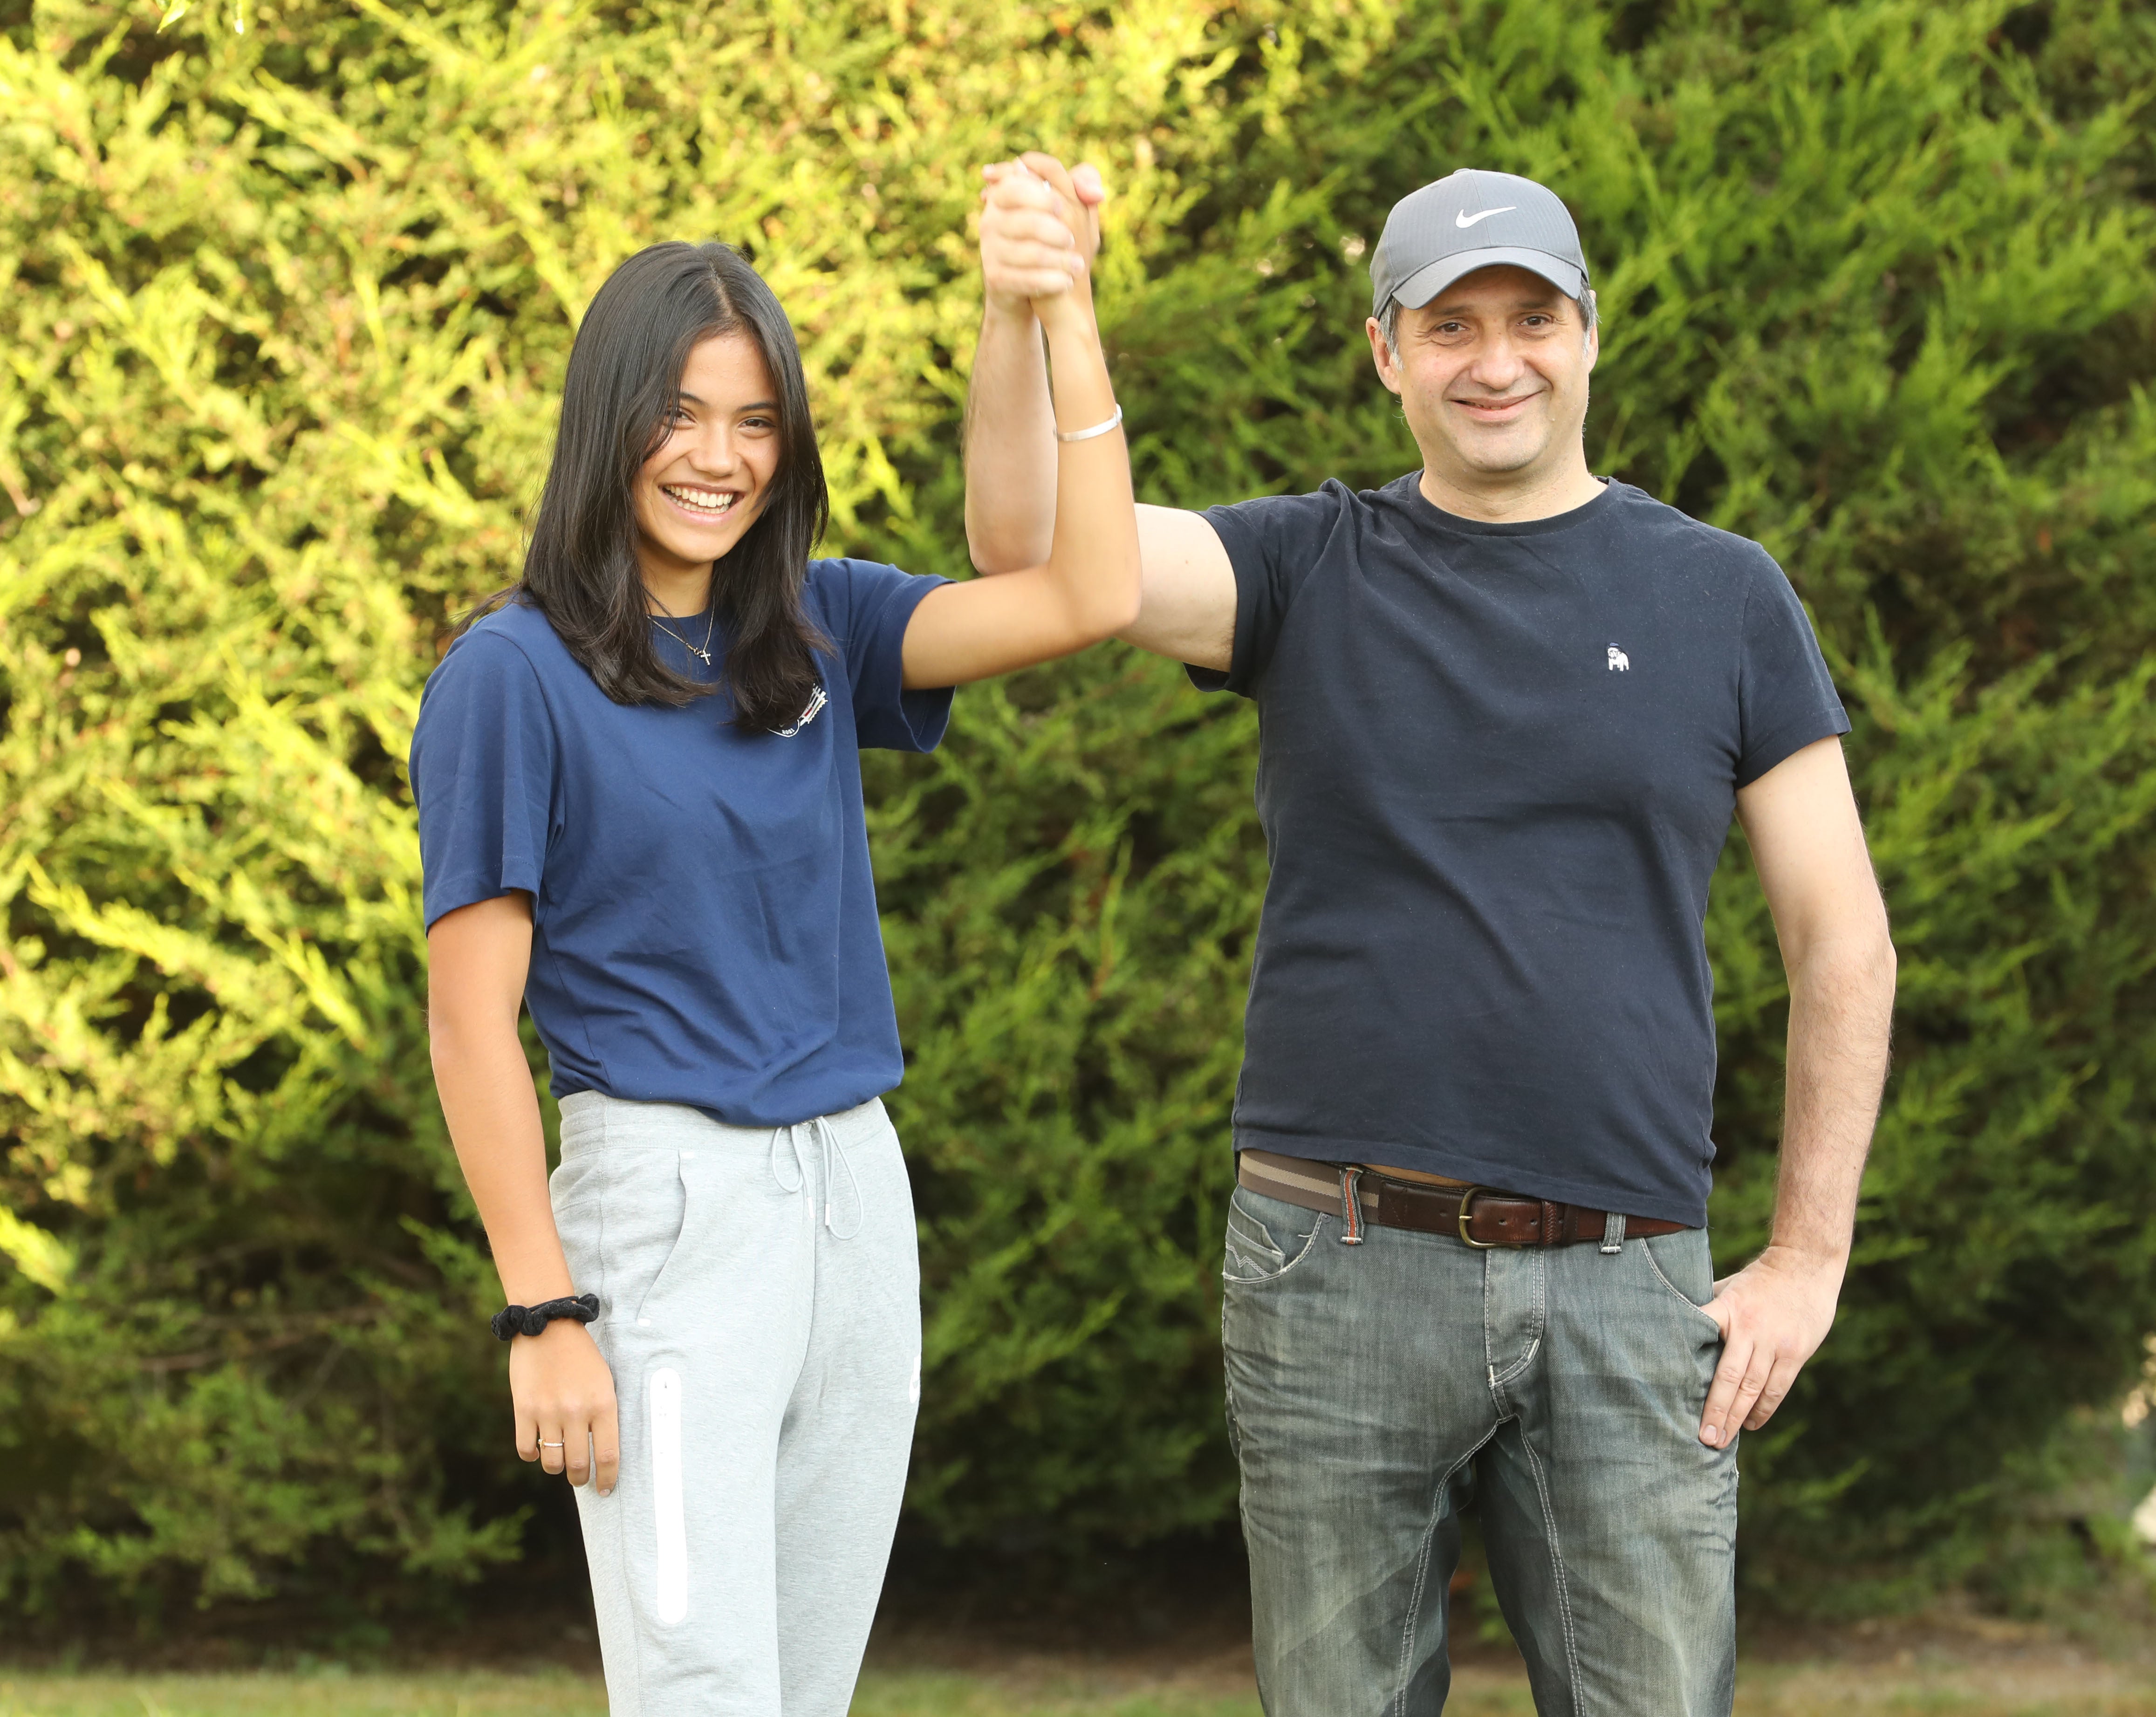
<box><xmin>1772</xmin><ymin>936</ymin><xmax>1895</xmax><ymax>1264</ymax></box>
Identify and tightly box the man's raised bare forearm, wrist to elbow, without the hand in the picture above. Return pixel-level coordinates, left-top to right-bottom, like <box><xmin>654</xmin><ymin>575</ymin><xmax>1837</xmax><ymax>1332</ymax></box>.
<box><xmin>966</xmin><ymin>300</ymin><xmax>1056</xmax><ymax>572</ymax></box>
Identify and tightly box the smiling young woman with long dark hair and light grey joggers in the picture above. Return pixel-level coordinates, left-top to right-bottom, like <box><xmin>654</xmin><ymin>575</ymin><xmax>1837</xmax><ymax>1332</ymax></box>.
<box><xmin>412</xmin><ymin>181</ymin><xmax>1138</xmax><ymax>1717</ymax></box>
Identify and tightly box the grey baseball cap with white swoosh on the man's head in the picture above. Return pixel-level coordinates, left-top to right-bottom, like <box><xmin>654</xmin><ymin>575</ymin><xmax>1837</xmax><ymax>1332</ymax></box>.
<box><xmin>1369</xmin><ymin>166</ymin><xmax>1587</xmax><ymax>315</ymax></box>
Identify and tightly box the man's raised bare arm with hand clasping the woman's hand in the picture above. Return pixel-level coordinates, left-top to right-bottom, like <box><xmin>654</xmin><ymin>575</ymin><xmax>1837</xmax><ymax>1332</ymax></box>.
<box><xmin>966</xmin><ymin>153</ymin><xmax>1235</xmax><ymax>669</ymax></box>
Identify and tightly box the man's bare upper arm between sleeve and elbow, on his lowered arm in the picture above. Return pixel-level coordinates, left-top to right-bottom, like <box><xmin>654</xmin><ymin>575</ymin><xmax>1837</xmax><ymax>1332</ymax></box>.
<box><xmin>1738</xmin><ymin>738</ymin><xmax>1887</xmax><ymax>962</ymax></box>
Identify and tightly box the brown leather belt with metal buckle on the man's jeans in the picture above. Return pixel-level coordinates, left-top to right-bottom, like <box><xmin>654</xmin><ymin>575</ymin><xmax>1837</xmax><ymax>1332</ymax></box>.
<box><xmin>1235</xmin><ymin>1149</ymin><xmax>1686</xmax><ymax>1251</ymax></box>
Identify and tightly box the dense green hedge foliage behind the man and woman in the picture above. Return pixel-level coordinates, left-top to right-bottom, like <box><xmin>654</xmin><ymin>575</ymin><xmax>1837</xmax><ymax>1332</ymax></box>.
<box><xmin>0</xmin><ymin>0</ymin><xmax>2156</xmax><ymax>1607</ymax></box>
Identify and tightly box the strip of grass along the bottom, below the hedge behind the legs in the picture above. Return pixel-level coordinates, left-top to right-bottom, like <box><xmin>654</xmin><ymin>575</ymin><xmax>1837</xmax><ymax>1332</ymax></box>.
<box><xmin>0</xmin><ymin>1652</ymin><xmax>2156</xmax><ymax>1717</ymax></box>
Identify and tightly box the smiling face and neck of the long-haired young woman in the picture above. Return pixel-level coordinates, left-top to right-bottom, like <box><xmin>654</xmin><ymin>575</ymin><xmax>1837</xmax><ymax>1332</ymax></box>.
<box><xmin>632</xmin><ymin>335</ymin><xmax>778</xmax><ymax>615</ymax></box>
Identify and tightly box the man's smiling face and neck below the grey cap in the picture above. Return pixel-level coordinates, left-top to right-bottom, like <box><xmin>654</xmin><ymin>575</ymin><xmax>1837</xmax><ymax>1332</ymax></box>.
<box><xmin>1369</xmin><ymin>267</ymin><xmax>1598</xmax><ymax>494</ymax></box>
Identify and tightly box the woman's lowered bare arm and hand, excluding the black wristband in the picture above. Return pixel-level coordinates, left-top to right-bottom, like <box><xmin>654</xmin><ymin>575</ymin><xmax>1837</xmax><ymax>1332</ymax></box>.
<box><xmin>427</xmin><ymin>893</ymin><xmax>621</xmax><ymax>1497</ymax></box>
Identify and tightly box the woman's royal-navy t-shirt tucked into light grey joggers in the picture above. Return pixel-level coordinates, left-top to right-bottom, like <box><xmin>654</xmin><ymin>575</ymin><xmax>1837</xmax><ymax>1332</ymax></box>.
<box><xmin>412</xmin><ymin>561</ymin><xmax>951</xmax><ymax>1126</ymax></box>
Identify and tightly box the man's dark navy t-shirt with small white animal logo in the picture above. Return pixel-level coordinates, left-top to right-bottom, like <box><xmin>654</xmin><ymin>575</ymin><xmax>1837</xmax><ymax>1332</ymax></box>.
<box><xmin>1192</xmin><ymin>472</ymin><xmax>1848</xmax><ymax>1225</ymax></box>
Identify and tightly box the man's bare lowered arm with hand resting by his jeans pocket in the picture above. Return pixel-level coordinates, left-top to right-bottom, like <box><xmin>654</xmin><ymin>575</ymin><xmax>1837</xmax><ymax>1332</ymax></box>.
<box><xmin>1699</xmin><ymin>740</ymin><xmax>1895</xmax><ymax>1447</ymax></box>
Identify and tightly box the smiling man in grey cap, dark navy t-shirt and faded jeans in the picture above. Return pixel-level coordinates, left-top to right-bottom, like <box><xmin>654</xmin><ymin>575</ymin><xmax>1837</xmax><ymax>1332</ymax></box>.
<box><xmin>966</xmin><ymin>157</ymin><xmax>1895</xmax><ymax>1717</ymax></box>
